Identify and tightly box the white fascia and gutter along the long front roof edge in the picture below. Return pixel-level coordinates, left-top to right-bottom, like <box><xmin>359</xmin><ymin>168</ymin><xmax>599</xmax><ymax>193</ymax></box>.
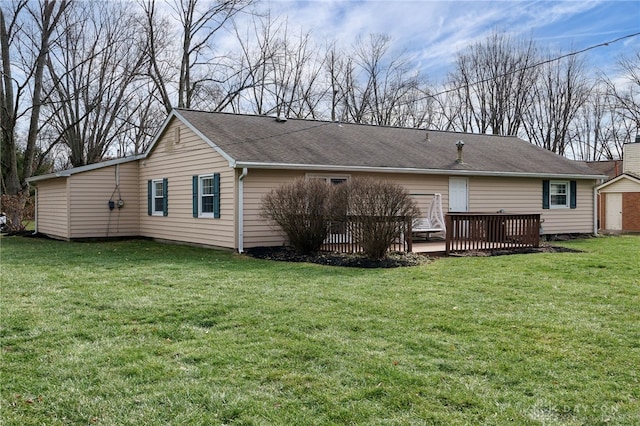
<box><xmin>231</xmin><ymin>161</ymin><xmax>606</xmax><ymax>180</ymax></box>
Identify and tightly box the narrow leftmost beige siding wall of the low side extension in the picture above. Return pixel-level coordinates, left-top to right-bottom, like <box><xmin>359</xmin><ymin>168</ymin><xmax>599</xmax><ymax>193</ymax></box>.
<box><xmin>36</xmin><ymin>177</ymin><xmax>70</xmax><ymax>240</ymax></box>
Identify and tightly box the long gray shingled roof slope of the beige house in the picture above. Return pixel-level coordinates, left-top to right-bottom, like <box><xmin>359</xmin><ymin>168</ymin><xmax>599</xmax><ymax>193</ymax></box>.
<box><xmin>175</xmin><ymin>110</ymin><xmax>599</xmax><ymax>178</ymax></box>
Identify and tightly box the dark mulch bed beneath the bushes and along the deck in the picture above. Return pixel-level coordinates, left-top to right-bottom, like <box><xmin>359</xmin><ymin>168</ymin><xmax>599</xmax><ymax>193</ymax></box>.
<box><xmin>246</xmin><ymin>244</ymin><xmax>580</xmax><ymax>268</ymax></box>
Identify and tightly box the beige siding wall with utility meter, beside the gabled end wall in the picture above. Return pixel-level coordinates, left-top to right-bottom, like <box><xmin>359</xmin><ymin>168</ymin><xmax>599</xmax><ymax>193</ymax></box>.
<box><xmin>68</xmin><ymin>162</ymin><xmax>140</xmax><ymax>238</ymax></box>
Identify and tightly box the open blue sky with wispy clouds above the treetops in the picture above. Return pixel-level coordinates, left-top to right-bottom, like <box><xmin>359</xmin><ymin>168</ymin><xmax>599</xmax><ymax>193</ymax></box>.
<box><xmin>260</xmin><ymin>0</ymin><xmax>640</xmax><ymax>81</ymax></box>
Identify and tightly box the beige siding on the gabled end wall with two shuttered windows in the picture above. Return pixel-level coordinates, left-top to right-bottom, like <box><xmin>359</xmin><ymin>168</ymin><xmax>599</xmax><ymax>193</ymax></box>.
<box><xmin>139</xmin><ymin>119</ymin><xmax>236</xmax><ymax>248</ymax></box>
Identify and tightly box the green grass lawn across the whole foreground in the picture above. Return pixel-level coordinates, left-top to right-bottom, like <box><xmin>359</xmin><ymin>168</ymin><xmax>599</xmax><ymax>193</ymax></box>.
<box><xmin>0</xmin><ymin>236</ymin><xmax>640</xmax><ymax>425</ymax></box>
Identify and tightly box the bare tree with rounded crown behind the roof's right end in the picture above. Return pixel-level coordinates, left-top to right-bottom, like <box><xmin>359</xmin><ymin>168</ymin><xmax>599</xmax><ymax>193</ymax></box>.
<box><xmin>523</xmin><ymin>56</ymin><xmax>591</xmax><ymax>155</ymax></box>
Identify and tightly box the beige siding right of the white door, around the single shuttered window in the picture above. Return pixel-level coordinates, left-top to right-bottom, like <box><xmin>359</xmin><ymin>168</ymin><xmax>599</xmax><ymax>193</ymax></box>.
<box><xmin>469</xmin><ymin>177</ymin><xmax>596</xmax><ymax>234</ymax></box>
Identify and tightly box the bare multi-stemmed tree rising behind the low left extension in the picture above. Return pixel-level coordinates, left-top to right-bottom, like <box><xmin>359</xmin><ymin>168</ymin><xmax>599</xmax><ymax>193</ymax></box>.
<box><xmin>47</xmin><ymin>2</ymin><xmax>146</xmax><ymax>167</ymax></box>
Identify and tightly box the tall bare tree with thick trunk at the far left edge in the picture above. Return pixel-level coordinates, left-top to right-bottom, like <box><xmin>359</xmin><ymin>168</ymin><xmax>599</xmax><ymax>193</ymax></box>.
<box><xmin>0</xmin><ymin>0</ymin><xmax>70</xmax><ymax>229</ymax></box>
